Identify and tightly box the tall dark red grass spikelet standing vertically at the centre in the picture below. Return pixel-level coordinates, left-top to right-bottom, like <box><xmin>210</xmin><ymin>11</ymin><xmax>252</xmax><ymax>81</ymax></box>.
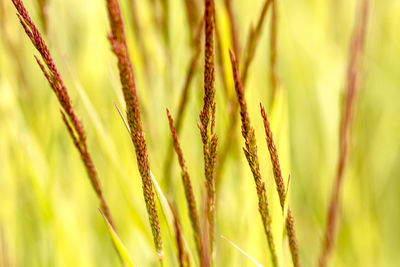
<box><xmin>198</xmin><ymin>0</ymin><xmax>218</xmax><ymax>255</ymax></box>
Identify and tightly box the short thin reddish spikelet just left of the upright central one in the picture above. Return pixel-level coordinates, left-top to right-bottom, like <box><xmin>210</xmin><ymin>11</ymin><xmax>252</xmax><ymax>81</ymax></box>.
<box><xmin>167</xmin><ymin>109</ymin><xmax>202</xmax><ymax>257</ymax></box>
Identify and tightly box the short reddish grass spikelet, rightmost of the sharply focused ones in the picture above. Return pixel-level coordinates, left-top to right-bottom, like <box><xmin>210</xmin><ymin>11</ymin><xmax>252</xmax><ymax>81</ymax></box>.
<box><xmin>260</xmin><ymin>103</ymin><xmax>300</xmax><ymax>267</ymax></box>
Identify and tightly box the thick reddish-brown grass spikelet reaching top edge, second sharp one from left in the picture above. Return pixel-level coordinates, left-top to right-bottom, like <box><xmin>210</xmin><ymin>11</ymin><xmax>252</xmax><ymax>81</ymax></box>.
<box><xmin>107</xmin><ymin>0</ymin><xmax>163</xmax><ymax>261</ymax></box>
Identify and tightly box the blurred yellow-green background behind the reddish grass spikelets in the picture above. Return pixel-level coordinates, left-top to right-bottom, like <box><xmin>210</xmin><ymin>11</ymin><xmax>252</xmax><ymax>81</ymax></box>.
<box><xmin>0</xmin><ymin>0</ymin><xmax>400</xmax><ymax>267</ymax></box>
